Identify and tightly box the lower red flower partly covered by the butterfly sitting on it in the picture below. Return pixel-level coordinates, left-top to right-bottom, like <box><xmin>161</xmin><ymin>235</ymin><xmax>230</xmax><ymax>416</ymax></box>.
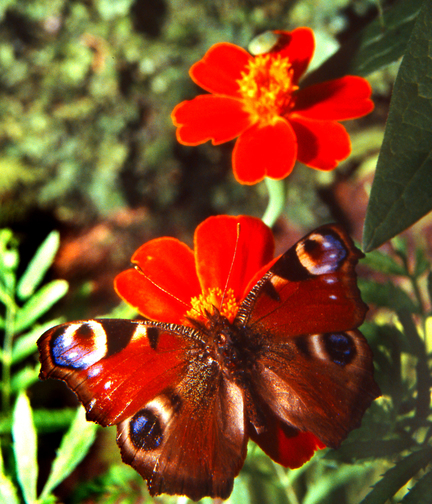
<box><xmin>115</xmin><ymin>216</ymin><xmax>324</xmax><ymax>468</ymax></box>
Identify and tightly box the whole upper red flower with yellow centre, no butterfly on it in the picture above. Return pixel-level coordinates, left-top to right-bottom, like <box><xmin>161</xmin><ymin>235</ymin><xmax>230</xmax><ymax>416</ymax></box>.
<box><xmin>171</xmin><ymin>28</ymin><xmax>374</xmax><ymax>184</ymax></box>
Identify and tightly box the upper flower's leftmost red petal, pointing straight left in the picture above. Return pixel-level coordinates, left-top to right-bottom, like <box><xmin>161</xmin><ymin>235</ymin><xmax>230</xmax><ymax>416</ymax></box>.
<box><xmin>171</xmin><ymin>95</ymin><xmax>251</xmax><ymax>145</ymax></box>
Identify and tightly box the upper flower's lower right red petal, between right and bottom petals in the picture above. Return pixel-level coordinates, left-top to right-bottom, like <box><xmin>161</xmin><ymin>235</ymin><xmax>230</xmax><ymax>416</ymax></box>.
<box><xmin>290</xmin><ymin>117</ymin><xmax>351</xmax><ymax>170</ymax></box>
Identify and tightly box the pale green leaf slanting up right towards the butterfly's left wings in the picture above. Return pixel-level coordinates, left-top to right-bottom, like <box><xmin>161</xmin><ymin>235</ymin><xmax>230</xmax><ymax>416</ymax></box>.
<box><xmin>41</xmin><ymin>408</ymin><xmax>97</xmax><ymax>498</ymax></box>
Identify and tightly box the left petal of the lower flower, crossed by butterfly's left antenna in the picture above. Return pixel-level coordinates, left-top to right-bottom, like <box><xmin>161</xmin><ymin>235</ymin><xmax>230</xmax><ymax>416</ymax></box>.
<box><xmin>114</xmin><ymin>238</ymin><xmax>201</xmax><ymax>324</ymax></box>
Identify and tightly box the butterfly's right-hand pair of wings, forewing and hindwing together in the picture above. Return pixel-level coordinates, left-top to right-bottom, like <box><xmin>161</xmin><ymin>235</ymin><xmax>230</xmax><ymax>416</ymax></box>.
<box><xmin>236</xmin><ymin>225</ymin><xmax>380</xmax><ymax>447</ymax></box>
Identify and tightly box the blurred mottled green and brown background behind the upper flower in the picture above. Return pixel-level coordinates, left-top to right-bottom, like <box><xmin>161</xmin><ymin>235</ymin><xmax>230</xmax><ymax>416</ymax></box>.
<box><xmin>0</xmin><ymin>0</ymin><xmax>397</xmax><ymax>316</ymax></box>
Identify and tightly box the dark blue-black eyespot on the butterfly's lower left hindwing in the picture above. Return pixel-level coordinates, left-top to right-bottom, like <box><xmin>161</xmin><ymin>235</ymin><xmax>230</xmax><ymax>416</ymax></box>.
<box><xmin>130</xmin><ymin>408</ymin><xmax>163</xmax><ymax>451</ymax></box>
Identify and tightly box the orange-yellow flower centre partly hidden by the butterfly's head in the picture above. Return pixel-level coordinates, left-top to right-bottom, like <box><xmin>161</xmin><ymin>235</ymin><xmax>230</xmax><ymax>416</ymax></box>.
<box><xmin>186</xmin><ymin>288</ymin><xmax>239</xmax><ymax>323</ymax></box>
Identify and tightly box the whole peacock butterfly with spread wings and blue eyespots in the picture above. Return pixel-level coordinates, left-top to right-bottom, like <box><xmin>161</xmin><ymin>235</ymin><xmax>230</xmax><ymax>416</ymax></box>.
<box><xmin>38</xmin><ymin>223</ymin><xmax>380</xmax><ymax>500</ymax></box>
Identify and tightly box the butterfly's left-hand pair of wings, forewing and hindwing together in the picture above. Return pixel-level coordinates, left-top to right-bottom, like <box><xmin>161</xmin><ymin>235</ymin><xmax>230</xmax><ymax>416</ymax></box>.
<box><xmin>38</xmin><ymin>319</ymin><xmax>248</xmax><ymax>500</ymax></box>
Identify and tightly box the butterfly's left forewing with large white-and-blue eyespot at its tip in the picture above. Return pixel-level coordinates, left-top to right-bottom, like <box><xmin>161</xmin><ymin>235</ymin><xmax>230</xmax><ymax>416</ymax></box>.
<box><xmin>38</xmin><ymin>319</ymin><xmax>186</xmax><ymax>426</ymax></box>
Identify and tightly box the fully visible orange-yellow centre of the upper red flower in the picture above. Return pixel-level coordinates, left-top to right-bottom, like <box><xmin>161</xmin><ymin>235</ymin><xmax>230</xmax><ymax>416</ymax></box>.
<box><xmin>237</xmin><ymin>54</ymin><xmax>298</xmax><ymax>125</ymax></box>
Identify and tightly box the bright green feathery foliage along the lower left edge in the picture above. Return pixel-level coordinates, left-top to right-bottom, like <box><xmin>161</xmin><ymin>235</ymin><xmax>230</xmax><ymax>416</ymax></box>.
<box><xmin>0</xmin><ymin>229</ymin><xmax>96</xmax><ymax>504</ymax></box>
